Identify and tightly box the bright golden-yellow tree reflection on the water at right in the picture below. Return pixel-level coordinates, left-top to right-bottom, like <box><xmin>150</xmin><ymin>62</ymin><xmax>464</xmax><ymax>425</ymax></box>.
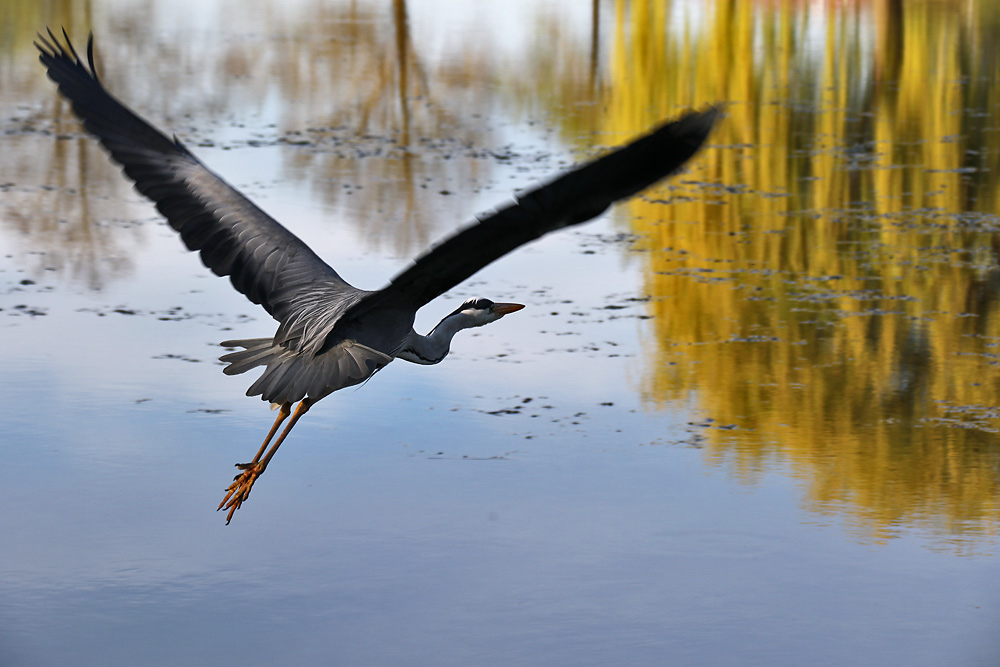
<box><xmin>603</xmin><ymin>0</ymin><xmax>1000</xmax><ymax>548</ymax></box>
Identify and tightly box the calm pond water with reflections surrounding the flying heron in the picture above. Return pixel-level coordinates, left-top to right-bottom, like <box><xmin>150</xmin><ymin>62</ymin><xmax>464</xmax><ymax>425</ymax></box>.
<box><xmin>0</xmin><ymin>0</ymin><xmax>1000</xmax><ymax>666</ymax></box>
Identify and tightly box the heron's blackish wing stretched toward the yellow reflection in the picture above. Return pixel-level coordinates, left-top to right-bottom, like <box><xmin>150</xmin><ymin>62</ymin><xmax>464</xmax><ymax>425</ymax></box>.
<box><xmin>345</xmin><ymin>107</ymin><xmax>719</xmax><ymax>317</ymax></box>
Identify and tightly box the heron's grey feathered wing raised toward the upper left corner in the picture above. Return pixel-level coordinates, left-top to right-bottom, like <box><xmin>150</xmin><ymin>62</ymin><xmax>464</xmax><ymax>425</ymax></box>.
<box><xmin>35</xmin><ymin>30</ymin><xmax>359</xmax><ymax>322</ymax></box>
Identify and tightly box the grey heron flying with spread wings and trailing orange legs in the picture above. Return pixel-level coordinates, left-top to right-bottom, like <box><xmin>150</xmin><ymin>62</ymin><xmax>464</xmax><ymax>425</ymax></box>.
<box><xmin>35</xmin><ymin>30</ymin><xmax>719</xmax><ymax>524</ymax></box>
